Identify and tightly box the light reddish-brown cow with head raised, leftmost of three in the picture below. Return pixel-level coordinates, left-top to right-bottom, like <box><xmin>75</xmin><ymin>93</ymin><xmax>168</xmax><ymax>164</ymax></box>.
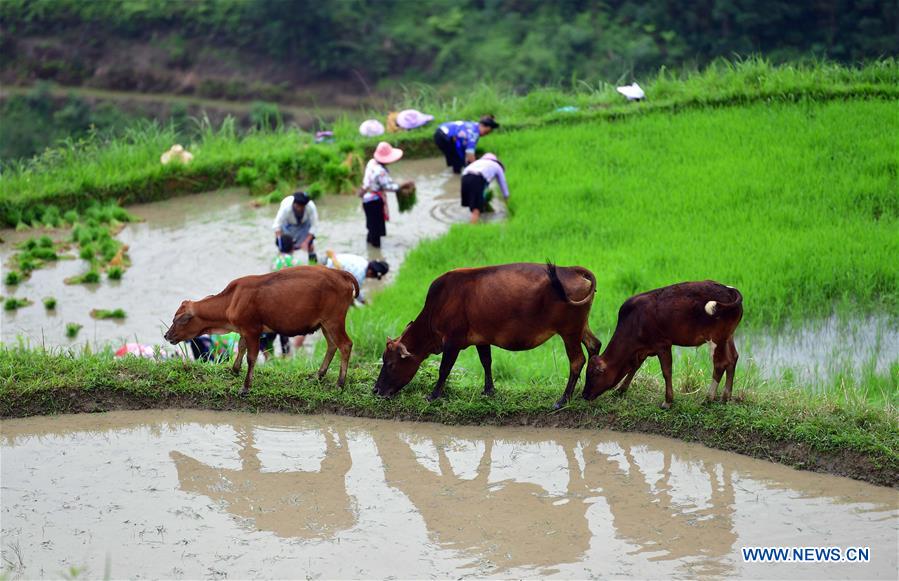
<box><xmin>165</xmin><ymin>266</ymin><xmax>359</xmax><ymax>395</ymax></box>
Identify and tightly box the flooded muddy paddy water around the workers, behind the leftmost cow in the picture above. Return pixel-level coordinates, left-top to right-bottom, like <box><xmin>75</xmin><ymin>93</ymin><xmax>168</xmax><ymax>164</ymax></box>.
<box><xmin>0</xmin><ymin>159</ymin><xmax>492</xmax><ymax>346</ymax></box>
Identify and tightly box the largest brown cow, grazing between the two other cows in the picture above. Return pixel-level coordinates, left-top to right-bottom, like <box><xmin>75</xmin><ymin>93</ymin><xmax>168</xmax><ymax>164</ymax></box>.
<box><xmin>374</xmin><ymin>263</ymin><xmax>602</xmax><ymax>408</ymax></box>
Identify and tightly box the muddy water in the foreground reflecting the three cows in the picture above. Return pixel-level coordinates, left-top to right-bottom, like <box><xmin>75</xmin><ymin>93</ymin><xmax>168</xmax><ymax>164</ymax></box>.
<box><xmin>0</xmin><ymin>410</ymin><xmax>899</xmax><ymax>579</ymax></box>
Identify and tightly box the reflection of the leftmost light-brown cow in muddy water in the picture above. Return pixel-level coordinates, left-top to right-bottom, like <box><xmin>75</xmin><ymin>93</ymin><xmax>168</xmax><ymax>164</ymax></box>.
<box><xmin>169</xmin><ymin>428</ymin><xmax>356</xmax><ymax>539</ymax></box>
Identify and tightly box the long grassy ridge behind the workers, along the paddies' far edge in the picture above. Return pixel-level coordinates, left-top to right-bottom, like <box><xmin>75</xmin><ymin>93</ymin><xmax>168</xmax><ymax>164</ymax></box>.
<box><xmin>0</xmin><ymin>58</ymin><xmax>899</xmax><ymax>226</ymax></box>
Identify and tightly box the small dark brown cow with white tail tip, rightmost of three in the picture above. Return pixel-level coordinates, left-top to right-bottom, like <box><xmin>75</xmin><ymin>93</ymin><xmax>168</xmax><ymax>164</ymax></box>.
<box><xmin>584</xmin><ymin>280</ymin><xmax>743</xmax><ymax>409</ymax></box>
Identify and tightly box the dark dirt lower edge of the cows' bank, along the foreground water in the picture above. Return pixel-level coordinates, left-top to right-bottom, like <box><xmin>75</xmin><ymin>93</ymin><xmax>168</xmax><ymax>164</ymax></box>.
<box><xmin>0</xmin><ymin>388</ymin><xmax>899</xmax><ymax>489</ymax></box>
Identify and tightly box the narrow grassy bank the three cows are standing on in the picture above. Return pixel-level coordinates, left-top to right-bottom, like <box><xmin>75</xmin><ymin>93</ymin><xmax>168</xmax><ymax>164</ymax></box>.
<box><xmin>0</xmin><ymin>349</ymin><xmax>899</xmax><ymax>486</ymax></box>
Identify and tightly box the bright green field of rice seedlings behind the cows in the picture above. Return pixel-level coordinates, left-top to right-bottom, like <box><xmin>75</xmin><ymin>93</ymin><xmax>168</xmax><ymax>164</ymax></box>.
<box><xmin>352</xmin><ymin>96</ymin><xmax>899</xmax><ymax>403</ymax></box>
